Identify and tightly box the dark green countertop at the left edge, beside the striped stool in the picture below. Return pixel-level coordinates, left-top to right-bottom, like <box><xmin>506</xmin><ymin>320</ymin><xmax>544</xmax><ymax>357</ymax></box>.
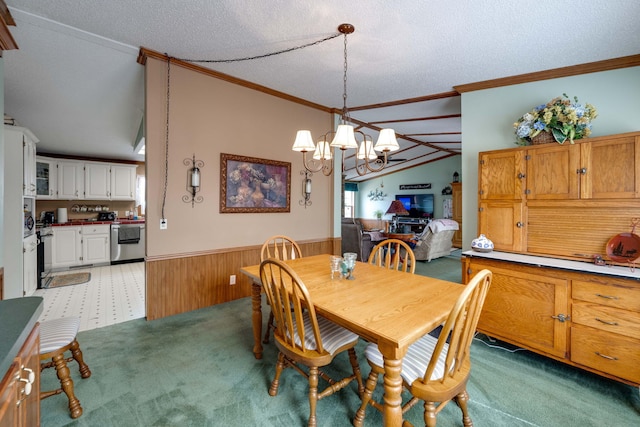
<box><xmin>0</xmin><ymin>297</ymin><xmax>44</xmax><ymax>379</ymax></box>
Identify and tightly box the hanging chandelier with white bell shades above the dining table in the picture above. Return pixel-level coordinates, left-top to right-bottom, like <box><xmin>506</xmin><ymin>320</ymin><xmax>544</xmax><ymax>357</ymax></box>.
<box><xmin>292</xmin><ymin>24</ymin><xmax>400</xmax><ymax>176</ymax></box>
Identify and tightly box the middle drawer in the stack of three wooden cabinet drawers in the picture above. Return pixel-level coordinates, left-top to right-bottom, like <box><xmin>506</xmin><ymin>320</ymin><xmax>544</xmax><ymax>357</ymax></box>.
<box><xmin>571</xmin><ymin>301</ymin><xmax>640</xmax><ymax>340</ymax></box>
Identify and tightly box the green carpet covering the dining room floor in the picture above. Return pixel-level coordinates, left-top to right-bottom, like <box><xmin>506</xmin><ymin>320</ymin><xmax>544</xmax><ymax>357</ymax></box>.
<box><xmin>41</xmin><ymin>257</ymin><xmax>640</xmax><ymax>427</ymax></box>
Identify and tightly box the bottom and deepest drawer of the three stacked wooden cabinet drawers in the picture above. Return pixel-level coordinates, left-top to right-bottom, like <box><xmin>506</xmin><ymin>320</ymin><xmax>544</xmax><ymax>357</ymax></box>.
<box><xmin>571</xmin><ymin>326</ymin><xmax>640</xmax><ymax>383</ymax></box>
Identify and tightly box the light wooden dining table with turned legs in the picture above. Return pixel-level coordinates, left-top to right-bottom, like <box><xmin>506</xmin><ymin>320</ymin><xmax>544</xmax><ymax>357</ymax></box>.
<box><xmin>240</xmin><ymin>254</ymin><xmax>464</xmax><ymax>427</ymax></box>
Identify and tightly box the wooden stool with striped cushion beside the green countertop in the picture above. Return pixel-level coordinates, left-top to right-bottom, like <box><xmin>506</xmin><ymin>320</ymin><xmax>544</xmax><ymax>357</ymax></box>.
<box><xmin>40</xmin><ymin>317</ymin><xmax>91</xmax><ymax>418</ymax></box>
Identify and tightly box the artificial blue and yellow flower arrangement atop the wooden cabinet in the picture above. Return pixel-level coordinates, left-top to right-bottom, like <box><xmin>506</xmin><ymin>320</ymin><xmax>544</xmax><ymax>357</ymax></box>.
<box><xmin>513</xmin><ymin>93</ymin><xmax>598</xmax><ymax>145</ymax></box>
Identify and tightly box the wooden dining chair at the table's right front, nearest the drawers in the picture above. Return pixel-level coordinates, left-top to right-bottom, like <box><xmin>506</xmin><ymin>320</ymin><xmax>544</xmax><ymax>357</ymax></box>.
<box><xmin>353</xmin><ymin>269</ymin><xmax>492</xmax><ymax>427</ymax></box>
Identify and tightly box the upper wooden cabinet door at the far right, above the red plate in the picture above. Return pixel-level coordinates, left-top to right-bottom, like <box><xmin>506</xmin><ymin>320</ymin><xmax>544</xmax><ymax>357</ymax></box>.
<box><xmin>580</xmin><ymin>136</ymin><xmax>640</xmax><ymax>199</ymax></box>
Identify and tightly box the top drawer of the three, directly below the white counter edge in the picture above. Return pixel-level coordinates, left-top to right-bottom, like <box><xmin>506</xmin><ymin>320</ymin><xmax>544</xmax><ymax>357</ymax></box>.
<box><xmin>571</xmin><ymin>280</ymin><xmax>640</xmax><ymax>312</ymax></box>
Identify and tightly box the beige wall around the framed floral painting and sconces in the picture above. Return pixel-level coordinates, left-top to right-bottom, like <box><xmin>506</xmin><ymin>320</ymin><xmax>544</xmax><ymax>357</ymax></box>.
<box><xmin>145</xmin><ymin>58</ymin><xmax>333</xmax><ymax>259</ymax></box>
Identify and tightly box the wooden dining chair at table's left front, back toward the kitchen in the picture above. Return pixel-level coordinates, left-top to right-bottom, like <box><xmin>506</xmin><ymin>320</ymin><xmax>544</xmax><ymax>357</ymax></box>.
<box><xmin>260</xmin><ymin>258</ymin><xmax>364</xmax><ymax>427</ymax></box>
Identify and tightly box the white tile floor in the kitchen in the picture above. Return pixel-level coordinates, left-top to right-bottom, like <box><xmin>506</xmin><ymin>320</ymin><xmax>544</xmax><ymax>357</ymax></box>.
<box><xmin>34</xmin><ymin>262</ymin><xmax>145</xmax><ymax>331</ymax></box>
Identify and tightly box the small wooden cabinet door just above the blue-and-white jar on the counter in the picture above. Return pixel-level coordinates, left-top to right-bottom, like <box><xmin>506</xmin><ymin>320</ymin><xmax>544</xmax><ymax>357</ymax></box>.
<box><xmin>478</xmin><ymin>200</ymin><xmax>526</xmax><ymax>252</ymax></box>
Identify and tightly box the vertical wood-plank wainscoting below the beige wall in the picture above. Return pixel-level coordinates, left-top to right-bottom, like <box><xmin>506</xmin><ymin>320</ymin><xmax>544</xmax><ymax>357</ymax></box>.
<box><xmin>145</xmin><ymin>238</ymin><xmax>341</xmax><ymax>320</ymax></box>
